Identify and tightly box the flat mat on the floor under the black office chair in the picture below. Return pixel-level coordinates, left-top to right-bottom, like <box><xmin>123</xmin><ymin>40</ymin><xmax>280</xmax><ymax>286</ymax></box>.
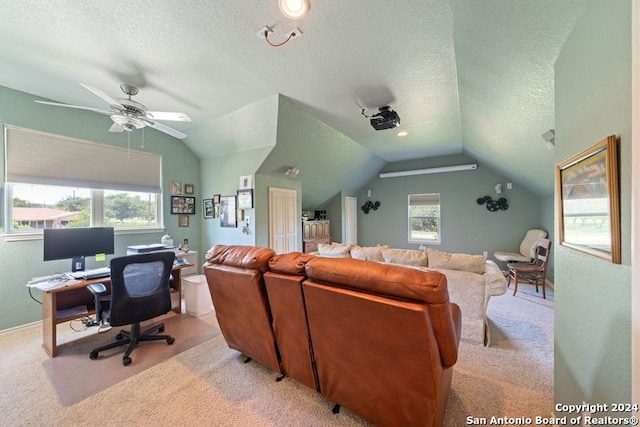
<box><xmin>42</xmin><ymin>314</ymin><xmax>220</xmax><ymax>406</ymax></box>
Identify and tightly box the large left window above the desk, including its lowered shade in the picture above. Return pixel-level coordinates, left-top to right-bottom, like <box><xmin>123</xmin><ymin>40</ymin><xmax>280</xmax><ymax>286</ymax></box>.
<box><xmin>5</xmin><ymin>126</ymin><xmax>162</xmax><ymax>234</ymax></box>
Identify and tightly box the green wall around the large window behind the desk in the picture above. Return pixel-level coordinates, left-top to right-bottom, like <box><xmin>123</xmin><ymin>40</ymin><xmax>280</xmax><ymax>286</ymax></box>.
<box><xmin>0</xmin><ymin>87</ymin><xmax>202</xmax><ymax>330</ymax></box>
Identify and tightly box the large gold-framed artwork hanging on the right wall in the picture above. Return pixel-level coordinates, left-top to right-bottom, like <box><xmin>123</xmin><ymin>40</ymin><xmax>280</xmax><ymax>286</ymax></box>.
<box><xmin>556</xmin><ymin>135</ymin><xmax>621</xmax><ymax>264</ymax></box>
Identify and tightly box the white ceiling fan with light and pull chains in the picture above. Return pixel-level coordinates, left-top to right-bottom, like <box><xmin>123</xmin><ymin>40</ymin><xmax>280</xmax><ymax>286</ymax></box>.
<box><xmin>36</xmin><ymin>83</ymin><xmax>191</xmax><ymax>139</ymax></box>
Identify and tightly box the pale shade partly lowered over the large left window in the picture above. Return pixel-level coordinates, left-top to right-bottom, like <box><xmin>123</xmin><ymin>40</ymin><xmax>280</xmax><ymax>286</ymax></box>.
<box><xmin>4</xmin><ymin>125</ymin><xmax>162</xmax><ymax>193</ymax></box>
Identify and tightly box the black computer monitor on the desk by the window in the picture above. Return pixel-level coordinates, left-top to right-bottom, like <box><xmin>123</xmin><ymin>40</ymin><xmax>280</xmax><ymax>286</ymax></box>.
<box><xmin>43</xmin><ymin>227</ymin><xmax>113</xmax><ymax>271</ymax></box>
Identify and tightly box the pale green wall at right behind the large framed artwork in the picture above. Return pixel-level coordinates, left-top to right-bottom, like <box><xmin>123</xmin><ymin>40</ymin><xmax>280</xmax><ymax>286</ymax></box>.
<box><xmin>554</xmin><ymin>0</ymin><xmax>632</xmax><ymax>415</ymax></box>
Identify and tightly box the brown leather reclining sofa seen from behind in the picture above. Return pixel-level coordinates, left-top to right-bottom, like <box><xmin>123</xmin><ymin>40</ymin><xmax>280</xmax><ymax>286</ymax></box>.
<box><xmin>204</xmin><ymin>245</ymin><xmax>461</xmax><ymax>426</ymax></box>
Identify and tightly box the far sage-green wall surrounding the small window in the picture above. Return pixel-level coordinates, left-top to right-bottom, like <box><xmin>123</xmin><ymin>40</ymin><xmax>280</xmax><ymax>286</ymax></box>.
<box><xmin>358</xmin><ymin>155</ymin><xmax>543</xmax><ymax>258</ymax></box>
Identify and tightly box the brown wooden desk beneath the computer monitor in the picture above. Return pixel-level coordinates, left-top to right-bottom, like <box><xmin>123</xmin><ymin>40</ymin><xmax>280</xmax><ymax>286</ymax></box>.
<box><xmin>42</xmin><ymin>264</ymin><xmax>193</xmax><ymax>357</ymax></box>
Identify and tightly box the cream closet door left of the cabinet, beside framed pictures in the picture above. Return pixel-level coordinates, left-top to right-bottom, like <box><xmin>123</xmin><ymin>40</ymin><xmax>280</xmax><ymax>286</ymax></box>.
<box><xmin>269</xmin><ymin>187</ymin><xmax>302</xmax><ymax>254</ymax></box>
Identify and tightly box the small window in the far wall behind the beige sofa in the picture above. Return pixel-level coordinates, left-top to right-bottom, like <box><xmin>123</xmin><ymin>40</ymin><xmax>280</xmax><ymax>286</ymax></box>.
<box><xmin>408</xmin><ymin>193</ymin><xmax>441</xmax><ymax>243</ymax></box>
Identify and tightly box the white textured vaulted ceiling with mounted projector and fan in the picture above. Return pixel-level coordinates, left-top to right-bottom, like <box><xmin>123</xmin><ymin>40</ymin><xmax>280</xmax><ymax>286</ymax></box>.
<box><xmin>0</xmin><ymin>0</ymin><xmax>586</xmax><ymax>194</ymax></box>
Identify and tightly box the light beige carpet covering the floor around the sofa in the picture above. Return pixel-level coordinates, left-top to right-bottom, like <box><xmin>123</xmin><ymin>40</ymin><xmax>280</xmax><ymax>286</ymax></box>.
<box><xmin>0</xmin><ymin>290</ymin><xmax>553</xmax><ymax>427</ymax></box>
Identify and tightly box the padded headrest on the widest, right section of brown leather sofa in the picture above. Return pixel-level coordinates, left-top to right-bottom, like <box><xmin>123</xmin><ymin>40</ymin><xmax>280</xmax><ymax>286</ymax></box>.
<box><xmin>305</xmin><ymin>257</ymin><xmax>449</xmax><ymax>304</ymax></box>
